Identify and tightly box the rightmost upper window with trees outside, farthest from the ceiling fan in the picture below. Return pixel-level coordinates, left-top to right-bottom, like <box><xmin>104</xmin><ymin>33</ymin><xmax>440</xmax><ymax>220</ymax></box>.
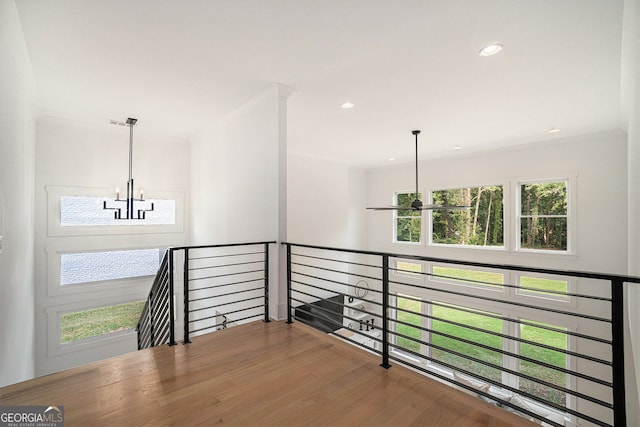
<box><xmin>517</xmin><ymin>180</ymin><xmax>569</xmax><ymax>251</ymax></box>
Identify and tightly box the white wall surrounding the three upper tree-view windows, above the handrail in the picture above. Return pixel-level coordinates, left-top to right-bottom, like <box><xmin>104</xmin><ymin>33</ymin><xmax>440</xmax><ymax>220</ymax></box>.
<box><xmin>368</xmin><ymin>132</ymin><xmax>627</xmax><ymax>274</ymax></box>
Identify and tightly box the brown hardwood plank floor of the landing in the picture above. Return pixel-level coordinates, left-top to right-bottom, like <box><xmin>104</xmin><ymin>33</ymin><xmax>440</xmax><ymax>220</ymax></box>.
<box><xmin>0</xmin><ymin>322</ymin><xmax>534</xmax><ymax>427</ymax></box>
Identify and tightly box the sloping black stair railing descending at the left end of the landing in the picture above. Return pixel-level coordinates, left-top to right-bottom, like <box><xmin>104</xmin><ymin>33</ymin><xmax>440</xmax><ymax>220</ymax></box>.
<box><xmin>136</xmin><ymin>249</ymin><xmax>176</xmax><ymax>350</ymax></box>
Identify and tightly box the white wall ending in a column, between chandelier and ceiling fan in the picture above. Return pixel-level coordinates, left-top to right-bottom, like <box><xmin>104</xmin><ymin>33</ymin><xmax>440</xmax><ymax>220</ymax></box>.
<box><xmin>191</xmin><ymin>85</ymin><xmax>291</xmax><ymax>318</ymax></box>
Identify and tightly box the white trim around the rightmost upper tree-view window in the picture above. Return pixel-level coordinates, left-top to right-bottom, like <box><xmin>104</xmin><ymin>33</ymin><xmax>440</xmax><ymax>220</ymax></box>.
<box><xmin>512</xmin><ymin>178</ymin><xmax>578</xmax><ymax>258</ymax></box>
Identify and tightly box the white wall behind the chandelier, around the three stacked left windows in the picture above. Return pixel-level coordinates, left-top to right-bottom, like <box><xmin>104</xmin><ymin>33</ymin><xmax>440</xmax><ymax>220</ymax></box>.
<box><xmin>35</xmin><ymin>117</ymin><xmax>190</xmax><ymax>375</ymax></box>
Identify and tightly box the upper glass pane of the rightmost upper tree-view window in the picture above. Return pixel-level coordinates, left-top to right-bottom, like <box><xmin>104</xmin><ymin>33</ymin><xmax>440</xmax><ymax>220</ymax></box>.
<box><xmin>520</xmin><ymin>181</ymin><xmax>567</xmax><ymax>215</ymax></box>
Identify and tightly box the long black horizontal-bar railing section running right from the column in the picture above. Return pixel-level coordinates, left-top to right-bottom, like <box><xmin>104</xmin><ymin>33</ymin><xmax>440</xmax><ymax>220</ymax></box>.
<box><xmin>285</xmin><ymin>243</ymin><xmax>640</xmax><ymax>426</ymax></box>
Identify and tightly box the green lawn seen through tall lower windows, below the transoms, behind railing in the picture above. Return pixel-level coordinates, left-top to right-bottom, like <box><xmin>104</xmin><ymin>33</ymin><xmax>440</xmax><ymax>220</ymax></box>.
<box><xmin>396</xmin><ymin>297</ymin><xmax>567</xmax><ymax>404</ymax></box>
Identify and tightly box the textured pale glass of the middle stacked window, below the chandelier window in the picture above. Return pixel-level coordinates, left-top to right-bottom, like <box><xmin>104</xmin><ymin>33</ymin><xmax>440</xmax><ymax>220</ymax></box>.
<box><xmin>60</xmin><ymin>248</ymin><xmax>160</xmax><ymax>285</ymax></box>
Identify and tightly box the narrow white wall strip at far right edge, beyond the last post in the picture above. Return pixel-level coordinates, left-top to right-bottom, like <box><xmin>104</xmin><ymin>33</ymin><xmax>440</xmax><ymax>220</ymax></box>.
<box><xmin>620</xmin><ymin>0</ymin><xmax>640</xmax><ymax>424</ymax></box>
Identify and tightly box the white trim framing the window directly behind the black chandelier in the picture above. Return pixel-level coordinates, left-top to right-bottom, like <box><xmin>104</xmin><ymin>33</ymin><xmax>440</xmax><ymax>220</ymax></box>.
<box><xmin>46</xmin><ymin>185</ymin><xmax>185</xmax><ymax>237</ymax></box>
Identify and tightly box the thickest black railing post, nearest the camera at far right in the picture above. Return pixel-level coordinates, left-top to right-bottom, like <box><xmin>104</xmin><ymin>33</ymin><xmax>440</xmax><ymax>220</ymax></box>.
<box><xmin>611</xmin><ymin>279</ymin><xmax>627</xmax><ymax>427</ymax></box>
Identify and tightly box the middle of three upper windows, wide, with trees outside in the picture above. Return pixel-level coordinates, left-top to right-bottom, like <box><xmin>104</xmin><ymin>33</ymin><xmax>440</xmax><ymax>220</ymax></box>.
<box><xmin>431</xmin><ymin>185</ymin><xmax>504</xmax><ymax>246</ymax></box>
